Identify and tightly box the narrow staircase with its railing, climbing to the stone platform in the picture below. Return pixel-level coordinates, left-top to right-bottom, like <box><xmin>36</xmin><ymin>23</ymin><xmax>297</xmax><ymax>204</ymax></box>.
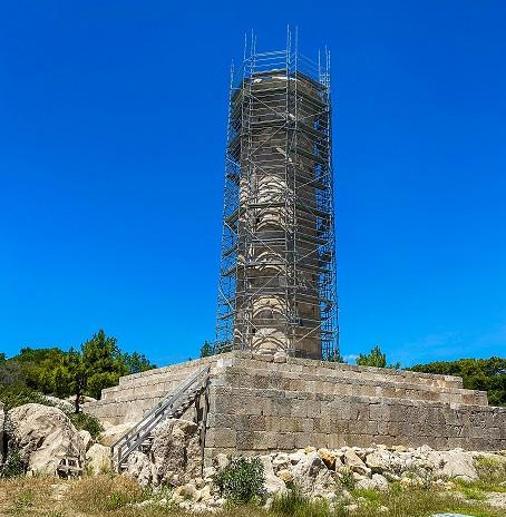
<box><xmin>111</xmin><ymin>366</ymin><xmax>210</xmax><ymax>472</ymax></box>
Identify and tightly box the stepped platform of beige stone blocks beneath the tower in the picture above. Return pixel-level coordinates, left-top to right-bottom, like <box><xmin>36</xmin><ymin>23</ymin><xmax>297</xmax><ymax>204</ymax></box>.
<box><xmin>88</xmin><ymin>352</ymin><xmax>506</xmax><ymax>458</ymax></box>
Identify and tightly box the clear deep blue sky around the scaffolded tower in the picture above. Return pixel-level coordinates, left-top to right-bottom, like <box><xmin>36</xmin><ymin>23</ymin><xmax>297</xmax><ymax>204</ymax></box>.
<box><xmin>0</xmin><ymin>0</ymin><xmax>506</xmax><ymax>365</ymax></box>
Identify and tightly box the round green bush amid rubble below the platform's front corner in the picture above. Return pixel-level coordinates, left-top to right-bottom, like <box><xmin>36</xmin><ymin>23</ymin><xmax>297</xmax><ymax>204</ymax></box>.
<box><xmin>214</xmin><ymin>458</ymin><xmax>264</xmax><ymax>504</ymax></box>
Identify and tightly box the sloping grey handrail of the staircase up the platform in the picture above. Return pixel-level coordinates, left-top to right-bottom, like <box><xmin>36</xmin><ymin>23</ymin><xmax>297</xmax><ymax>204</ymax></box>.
<box><xmin>111</xmin><ymin>366</ymin><xmax>210</xmax><ymax>467</ymax></box>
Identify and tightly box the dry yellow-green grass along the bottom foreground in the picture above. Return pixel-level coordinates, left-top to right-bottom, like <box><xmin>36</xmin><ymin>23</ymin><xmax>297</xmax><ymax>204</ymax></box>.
<box><xmin>0</xmin><ymin>475</ymin><xmax>505</xmax><ymax>517</ymax></box>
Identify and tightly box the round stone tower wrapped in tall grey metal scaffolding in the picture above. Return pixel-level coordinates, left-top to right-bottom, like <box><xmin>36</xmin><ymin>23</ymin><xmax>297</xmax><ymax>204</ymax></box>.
<box><xmin>216</xmin><ymin>28</ymin><xmax>339</xmax><ymax>359</ymax></box>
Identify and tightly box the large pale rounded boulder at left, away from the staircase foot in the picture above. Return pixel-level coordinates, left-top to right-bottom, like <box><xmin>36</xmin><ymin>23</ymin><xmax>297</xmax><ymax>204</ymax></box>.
<box><xmin>7</xmin><ymin>404</ymin><xmax>84</xmax><ymax>475</ymax></box>
